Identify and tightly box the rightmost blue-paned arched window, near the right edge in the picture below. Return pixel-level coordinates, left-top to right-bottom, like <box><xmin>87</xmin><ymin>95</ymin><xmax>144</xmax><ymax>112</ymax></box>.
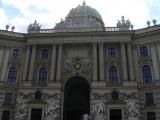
<box><xmin>142</xmin><ymin>65</ymin><xmax>152</xmax><ymax>84</ymax></box>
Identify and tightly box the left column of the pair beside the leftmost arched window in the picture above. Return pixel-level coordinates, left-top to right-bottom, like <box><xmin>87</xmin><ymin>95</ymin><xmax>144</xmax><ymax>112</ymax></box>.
<box><xmin>22</xmin><ymin>46</ymin><xmax>30</xmax><ymax>80</ymax></box>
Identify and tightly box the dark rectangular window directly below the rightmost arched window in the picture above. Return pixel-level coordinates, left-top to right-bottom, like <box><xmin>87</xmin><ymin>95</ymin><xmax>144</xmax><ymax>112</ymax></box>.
<box><xmin>145</xmin><ymin>93</ymin><xmax>154</xmax><ymax>105</ymax></box>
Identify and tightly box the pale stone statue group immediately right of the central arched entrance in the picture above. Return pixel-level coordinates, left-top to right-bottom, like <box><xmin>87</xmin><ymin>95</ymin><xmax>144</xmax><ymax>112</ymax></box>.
<box><xmin>92</xmin><ymin>99</ymin><xmax>105</xmax><ymax>120</ymax></box>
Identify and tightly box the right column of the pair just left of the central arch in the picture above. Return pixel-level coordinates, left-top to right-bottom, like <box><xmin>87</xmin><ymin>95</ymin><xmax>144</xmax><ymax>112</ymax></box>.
<box><xmin>56</xmin><ymin>44</ymin><xmax>63</xmax><ymax>81</ymax></box>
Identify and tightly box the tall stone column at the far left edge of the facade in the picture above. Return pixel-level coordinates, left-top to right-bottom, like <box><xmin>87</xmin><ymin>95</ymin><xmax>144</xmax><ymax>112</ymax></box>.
<box><xmin>0</xmin><ymin>48</ymin><xmax>10</xmax><ymax>81</ymax></box>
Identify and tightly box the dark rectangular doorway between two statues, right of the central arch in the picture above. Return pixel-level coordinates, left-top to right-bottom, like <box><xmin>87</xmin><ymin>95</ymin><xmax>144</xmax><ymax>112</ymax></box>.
<box><xmin>110</xmin><ymin>109</ymin><xmax>122</xmax><ymax>120</ymax></box>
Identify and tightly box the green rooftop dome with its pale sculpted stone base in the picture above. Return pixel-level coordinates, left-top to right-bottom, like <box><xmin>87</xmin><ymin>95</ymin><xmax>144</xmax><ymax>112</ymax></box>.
<box><xmin>55</xmin><ymin>2</ymin><xmax>104</xmax><ymax>28</ymax></box>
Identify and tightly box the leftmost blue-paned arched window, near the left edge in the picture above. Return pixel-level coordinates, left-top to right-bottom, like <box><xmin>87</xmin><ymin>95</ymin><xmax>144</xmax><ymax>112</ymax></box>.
<box><xmin>7</xmin><ymin>67</ymin><xmax>17</xmax><ymax>84</ymax></box>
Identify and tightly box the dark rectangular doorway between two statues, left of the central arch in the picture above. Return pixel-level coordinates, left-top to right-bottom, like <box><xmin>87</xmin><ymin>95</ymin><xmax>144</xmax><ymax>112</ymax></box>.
<box><xmin>31</xmin><ymin>108</ymin><xmax>42</xmax><ymax>120</ymax></box>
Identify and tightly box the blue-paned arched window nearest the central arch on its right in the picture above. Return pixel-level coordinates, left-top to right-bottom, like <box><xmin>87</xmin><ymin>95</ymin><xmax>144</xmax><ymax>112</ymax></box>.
<box><xmin>108</xmin><ymin>66</ymin><xmax>118</xmax><ymax>82</ymax></box>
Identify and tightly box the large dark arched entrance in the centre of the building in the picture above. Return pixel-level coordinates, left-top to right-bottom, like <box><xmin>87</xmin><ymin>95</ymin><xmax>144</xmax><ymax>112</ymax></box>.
<box><xmin>63</xmin><ymin>76</ymin><xmax>90</xmax><ymax>120</ymax></box>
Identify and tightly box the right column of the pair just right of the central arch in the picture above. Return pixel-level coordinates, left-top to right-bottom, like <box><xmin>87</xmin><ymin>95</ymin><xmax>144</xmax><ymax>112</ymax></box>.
<box><xmin>99</xmin><ymin>43</ymin><xmax>104</xmax><ymax>81</ymax></box>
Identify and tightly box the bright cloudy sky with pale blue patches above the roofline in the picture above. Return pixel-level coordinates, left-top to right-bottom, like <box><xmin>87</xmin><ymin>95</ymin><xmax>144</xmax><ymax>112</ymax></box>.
<box><xmin>0</xmin><ymin>0</ymin><xmax>160</xmax><ymax>32</ymax></box>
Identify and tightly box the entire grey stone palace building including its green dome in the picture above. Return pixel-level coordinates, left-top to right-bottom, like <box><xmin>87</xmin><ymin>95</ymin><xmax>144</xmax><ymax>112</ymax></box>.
<box><xmin>0</xmin><ymin>3</ymin><xmax>160</xmax><ymax>120</ymax></box>
